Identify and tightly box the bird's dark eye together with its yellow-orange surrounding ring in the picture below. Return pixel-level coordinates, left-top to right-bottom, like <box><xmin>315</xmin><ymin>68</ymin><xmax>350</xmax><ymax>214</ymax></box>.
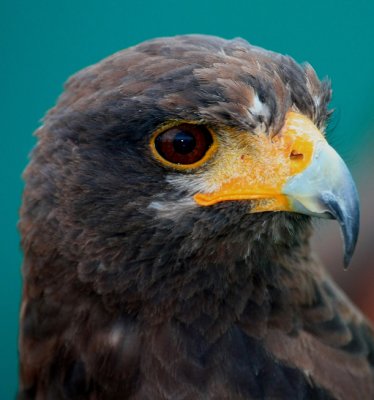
<box><xmin>150</xmin><ymin>122</ymin><xmax>217</xmax><ymax>170</ymax></box>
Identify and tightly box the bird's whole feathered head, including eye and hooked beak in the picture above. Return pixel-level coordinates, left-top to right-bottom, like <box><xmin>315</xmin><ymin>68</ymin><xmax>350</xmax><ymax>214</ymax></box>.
<box><xmin>24</xmin><ymin>36</ymin><xmax>358</xmax><ymax>306</ymax></box>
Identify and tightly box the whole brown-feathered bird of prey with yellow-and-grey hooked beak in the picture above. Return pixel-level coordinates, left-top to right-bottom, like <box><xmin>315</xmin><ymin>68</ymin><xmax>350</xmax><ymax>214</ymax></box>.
<box><xmin>18</xmin><ymin>35</ymin><xmax>374</xmax><ymax>400</ymax></box>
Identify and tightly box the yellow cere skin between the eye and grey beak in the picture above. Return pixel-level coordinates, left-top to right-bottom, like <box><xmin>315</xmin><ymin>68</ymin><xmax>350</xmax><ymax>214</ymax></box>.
<box><xmin>194</xmin><ymin>111</ymin><xmax>325</xmax><ymax>212</ymax></box>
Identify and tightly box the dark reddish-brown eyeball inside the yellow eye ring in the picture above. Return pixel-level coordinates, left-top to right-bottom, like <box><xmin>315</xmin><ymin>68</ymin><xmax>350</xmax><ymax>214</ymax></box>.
<box><xmin>154</xmin><ymin>124</ymin><xmax>213</xmax><ymax>166</ymax></box>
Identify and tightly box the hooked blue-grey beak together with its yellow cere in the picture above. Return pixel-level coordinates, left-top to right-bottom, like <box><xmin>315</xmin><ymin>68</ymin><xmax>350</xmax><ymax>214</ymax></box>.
<box><xmin>194</xmin><ymin>112</ymin><xmax>360</xmax><ymax>267</ymax></box>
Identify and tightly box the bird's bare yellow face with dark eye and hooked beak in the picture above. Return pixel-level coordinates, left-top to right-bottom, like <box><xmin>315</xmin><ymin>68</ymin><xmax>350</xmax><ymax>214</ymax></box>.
<box><xmin>150</xmin><ymin>109</ymin><xmax>358</xmax><ymax>265</ymax></box>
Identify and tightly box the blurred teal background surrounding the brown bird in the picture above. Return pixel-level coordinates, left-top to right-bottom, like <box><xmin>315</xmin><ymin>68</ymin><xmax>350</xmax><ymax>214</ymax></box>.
<box><xmin>0</xmin><ymin>0</ymin><xmax>374</xmax><ymax>400</ymax></box>
